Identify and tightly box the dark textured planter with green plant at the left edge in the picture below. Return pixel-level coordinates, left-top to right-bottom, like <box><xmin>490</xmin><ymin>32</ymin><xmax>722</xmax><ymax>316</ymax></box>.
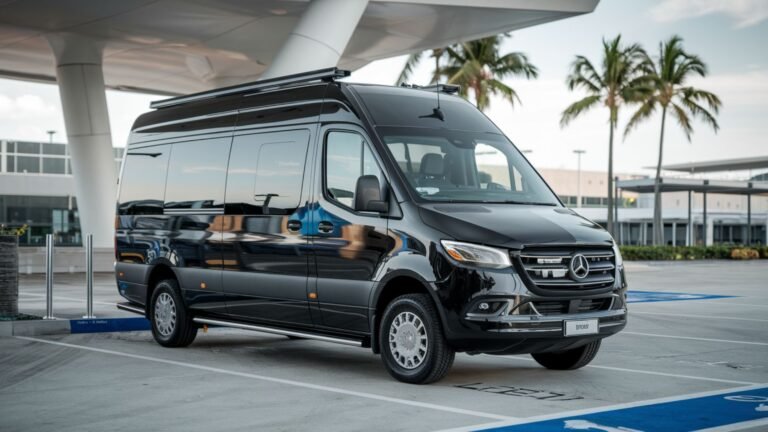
<box><xmin>0</xmin><ymin>225</ymin><xmax>27</xmax><ymax>318</ymax></box>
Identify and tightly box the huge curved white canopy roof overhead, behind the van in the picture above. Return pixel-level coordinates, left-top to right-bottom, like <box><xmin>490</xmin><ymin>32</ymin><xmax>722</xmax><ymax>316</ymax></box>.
<box><xmin>0</xmin><ymin>0</ymin><xmax>598</xmax><ymax>94</ymax></box>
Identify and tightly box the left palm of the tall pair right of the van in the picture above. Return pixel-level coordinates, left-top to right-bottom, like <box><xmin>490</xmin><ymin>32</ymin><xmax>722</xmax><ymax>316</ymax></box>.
<box><xmin>560</xmin><ymin>35</ymin><xmax>648</xmax><ymax>238</ymax></box>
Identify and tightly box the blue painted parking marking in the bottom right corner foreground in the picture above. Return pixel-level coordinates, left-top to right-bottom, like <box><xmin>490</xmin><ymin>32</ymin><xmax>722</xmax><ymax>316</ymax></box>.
<box><xmin>481</xmin><ymin>386</ymin><xmax>768</xmax><ymax>432</ymax></box>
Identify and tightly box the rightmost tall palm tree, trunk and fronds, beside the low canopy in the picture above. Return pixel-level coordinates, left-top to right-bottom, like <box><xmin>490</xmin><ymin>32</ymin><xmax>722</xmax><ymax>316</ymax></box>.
<box><xmin>624</xmin><ymin>36</ymin><xmax>721</xmax><ymax>245</ymax></box>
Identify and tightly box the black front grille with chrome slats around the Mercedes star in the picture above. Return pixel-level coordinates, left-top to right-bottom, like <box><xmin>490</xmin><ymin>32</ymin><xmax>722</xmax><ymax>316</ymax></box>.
<box><xmin>516</xmin><ymin>247</ymin><xmax>616</xmax><ymax>291</ymax></box>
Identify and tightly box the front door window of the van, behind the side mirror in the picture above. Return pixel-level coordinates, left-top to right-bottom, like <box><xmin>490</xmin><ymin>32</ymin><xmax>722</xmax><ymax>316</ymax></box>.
<box><xmin>324</xmin><ymin>131</ymin><xmax>385</xmax><ymax>208</ymax></box>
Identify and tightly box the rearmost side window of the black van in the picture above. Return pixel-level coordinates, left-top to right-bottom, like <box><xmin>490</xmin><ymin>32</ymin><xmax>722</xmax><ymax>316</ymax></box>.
<box><xmin>118</xmin><ymin>145</ymin><xmax>171</xmax><ymax>215</ymax></box>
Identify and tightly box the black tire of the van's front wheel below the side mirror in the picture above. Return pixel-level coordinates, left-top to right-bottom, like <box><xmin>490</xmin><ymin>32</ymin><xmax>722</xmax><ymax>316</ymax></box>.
<box><xmin>379</xmin><ymin>294</ymin><xmax>455</xmax><ymax>384</ymax></box>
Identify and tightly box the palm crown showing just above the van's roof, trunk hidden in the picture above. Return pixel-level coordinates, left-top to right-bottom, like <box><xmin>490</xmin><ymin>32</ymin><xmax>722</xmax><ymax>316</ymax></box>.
<box><xmin>397</xmin><ymin>35</ymin><xmax>538</xmax><ymax>110</ymax></box>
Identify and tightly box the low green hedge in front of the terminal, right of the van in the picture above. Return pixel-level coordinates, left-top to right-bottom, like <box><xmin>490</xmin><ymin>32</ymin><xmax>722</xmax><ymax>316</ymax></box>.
<box><xmin>620</xmin><ymin>245</ymin><xmax>768</xmax><ymax>261</ymax></box>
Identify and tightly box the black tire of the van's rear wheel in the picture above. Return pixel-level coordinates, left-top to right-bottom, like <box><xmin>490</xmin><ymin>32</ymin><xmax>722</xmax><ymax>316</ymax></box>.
<box><xmin>149</xmin><ymin>279</ymin><xmax>197</xmax><ymax>348</ymax></box>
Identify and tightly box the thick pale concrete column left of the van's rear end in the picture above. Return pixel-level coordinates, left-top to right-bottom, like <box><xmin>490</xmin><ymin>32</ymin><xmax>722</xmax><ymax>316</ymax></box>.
<box><xmin>48</xmin><ymin>34</ymin><xmax>117</xmax><ymax>247</ymax></box>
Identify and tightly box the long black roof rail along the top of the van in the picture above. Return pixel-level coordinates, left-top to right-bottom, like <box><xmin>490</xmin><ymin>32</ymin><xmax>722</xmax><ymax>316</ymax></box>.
<box><xmin>149</xmin><ymin>67</ymin><xmax>350</xmax><ymax>109</ymax></box>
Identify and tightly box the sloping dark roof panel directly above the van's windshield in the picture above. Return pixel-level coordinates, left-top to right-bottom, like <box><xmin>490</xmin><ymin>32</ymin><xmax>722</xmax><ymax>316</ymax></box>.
<box><xmin>353</xmin><ymin>85</ymin><xmax>501</xmax><ymax>133</ymax></box>
